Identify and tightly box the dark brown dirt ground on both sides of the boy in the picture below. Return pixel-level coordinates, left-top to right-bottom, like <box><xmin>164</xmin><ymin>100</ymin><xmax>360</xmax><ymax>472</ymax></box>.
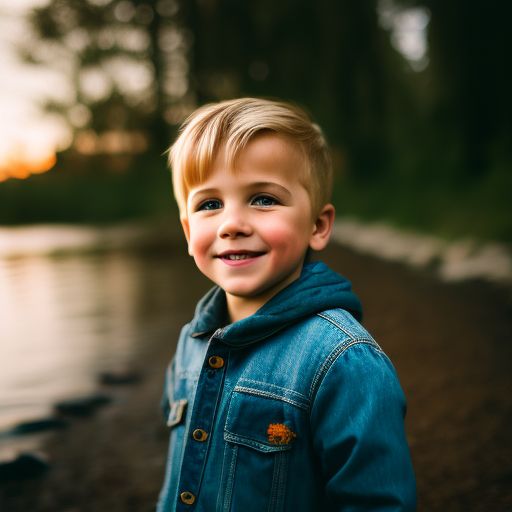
<box><xmin>0</xmin><ymin>242</ymin><xmax>512</xmax><ymax>512</ymax></box>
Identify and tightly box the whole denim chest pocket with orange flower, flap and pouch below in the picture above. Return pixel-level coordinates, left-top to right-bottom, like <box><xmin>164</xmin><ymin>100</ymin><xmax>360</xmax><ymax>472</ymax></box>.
<box><xmin>218</xmin><ymin>388</ymin><xmax>304</xmax><ymax>512</ymax></box>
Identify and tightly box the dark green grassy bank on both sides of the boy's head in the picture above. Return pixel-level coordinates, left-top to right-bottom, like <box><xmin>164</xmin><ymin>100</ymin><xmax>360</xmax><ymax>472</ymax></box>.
<box><xmin>0</xmin><ymin>150</ymin><xmax>512</xmax><ymax>243</ymax></box>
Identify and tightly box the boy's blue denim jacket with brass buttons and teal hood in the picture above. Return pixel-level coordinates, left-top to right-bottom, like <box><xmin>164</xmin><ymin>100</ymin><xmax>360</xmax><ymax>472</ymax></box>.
<box><xmin>158</xmin><ymin>262</ymin><xmax>416</xmax><ymax>512</ymax></box>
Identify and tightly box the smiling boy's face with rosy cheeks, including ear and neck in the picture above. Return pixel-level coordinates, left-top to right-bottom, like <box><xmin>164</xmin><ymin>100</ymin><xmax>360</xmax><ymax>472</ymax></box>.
<box><xmin>182</xmin><ymin>134</ymin><xmax>334</xmax><ymax>321</ymax></box>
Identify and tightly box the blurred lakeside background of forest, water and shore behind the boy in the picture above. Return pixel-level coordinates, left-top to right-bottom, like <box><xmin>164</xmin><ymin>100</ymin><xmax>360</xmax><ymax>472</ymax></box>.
<box><xmin>0</xmin><ymin>0</ymin><xmax>512</xmax><ymax>512</ymax></box>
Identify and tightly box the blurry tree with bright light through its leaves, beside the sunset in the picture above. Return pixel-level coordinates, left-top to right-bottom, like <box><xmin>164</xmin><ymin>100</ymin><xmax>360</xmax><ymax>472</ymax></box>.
<box><xmin>23</xmin><ymin>0</ymin><xmax>188</xmax><ymax>152</ymax></box>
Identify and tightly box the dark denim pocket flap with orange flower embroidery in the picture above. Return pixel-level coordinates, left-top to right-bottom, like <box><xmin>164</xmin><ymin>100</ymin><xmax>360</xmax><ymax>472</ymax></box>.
<box><xmin>224</xmin><ymin>390</ymin><xmax>301</xmax><ymax>452</ymax></box>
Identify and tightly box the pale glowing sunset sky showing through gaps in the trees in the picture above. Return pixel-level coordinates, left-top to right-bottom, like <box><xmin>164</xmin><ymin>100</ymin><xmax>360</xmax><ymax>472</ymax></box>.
<box><xmin>0</xmin><ymin>0</ymin><xmax>429</xmax><ymax>176</ymax></box>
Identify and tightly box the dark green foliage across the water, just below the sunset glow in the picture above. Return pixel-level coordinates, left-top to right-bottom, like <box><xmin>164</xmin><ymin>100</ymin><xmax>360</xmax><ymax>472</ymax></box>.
<box><xmin>0</xmin><ymin>154</ymin><xmax>177</xmax><ymax>224</ymax></box>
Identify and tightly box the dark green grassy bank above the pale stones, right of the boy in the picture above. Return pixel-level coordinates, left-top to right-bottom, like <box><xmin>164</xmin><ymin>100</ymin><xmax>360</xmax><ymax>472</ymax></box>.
<box><xmin>334</xmin><ymin>166</ymin><xmax>512</xmax><ymax>244</ymax></box>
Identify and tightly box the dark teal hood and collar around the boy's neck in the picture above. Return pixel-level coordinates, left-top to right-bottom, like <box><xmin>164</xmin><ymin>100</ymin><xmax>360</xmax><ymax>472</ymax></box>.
<box><xmin>191</xmin><ymin>262</ymin><xmax>362</xmax><ymax>346</ymax></box>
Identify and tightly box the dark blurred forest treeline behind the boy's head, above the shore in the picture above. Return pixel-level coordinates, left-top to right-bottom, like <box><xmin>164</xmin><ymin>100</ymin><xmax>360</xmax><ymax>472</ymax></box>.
<box><xmin>0</xmin><ymin>0</ymin><xmax>512</xmax><ymax>242</ymax></box>
